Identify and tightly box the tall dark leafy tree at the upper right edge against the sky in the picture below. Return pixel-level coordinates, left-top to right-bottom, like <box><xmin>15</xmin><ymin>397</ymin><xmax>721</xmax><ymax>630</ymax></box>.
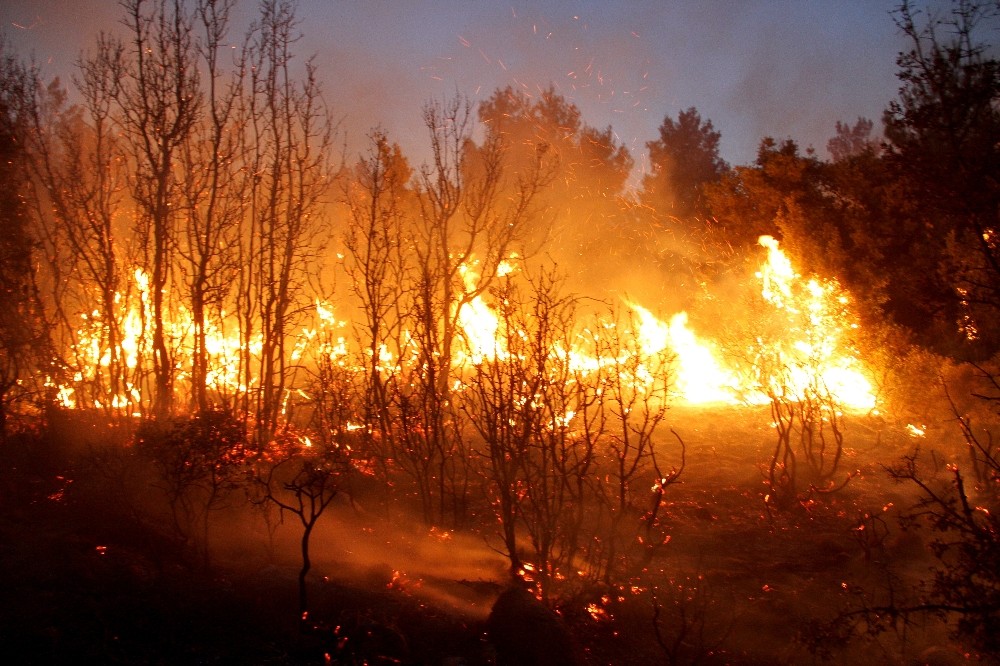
<box><xmin>884</xmin><ymin>0</ymin><xmax>1000</xmax><ymax>357</ymax></box>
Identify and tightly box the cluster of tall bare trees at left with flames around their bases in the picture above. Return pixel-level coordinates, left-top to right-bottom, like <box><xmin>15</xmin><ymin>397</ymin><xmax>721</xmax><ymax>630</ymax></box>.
<box><xmin>18</xmin><ymin>0</ymin><xmax>333</xmax><ymax>442</ymax></box>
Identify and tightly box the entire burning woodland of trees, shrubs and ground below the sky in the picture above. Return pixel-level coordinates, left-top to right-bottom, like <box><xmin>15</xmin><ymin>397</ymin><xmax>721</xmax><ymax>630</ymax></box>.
<box><xmin>0</xmin><ymin>0</ymin><xmax>1000</xmax><ymax>664</ymax></box>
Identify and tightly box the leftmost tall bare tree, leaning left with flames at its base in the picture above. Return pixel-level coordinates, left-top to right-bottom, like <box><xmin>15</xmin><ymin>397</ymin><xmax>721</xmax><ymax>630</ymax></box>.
<box><xmin>26</xmin><ymin>53</ymin><xmax>146</xmax><ymax>414</ymax></box>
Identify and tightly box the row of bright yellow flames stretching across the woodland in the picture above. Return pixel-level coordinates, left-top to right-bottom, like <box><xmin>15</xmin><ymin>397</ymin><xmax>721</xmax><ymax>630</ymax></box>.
<box><xmin>50</xmin><ymin>236</ymin><xmax>876</xmax><ymax>415</ymax></box>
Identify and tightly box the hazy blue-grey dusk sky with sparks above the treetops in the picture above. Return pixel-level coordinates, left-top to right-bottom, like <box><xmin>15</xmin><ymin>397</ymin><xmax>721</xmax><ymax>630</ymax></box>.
<box><xmin>0</xmin><ymin>0</ymin><xmax>906</xmax><ymax>173</ymax></box>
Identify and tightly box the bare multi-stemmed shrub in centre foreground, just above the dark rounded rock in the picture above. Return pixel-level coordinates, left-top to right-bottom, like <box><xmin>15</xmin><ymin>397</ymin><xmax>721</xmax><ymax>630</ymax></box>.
<box><xmin>461</xmin><ymin>269</ymin><xmax>597</xmax><ymax>598</ymax></box>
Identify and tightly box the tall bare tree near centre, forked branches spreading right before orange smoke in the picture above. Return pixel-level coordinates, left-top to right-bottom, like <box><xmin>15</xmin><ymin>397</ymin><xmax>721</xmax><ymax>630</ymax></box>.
<box><xmin>388</xmin><ymin>98</ymin><xmax>547</xmax><ymax>522</ymax></box>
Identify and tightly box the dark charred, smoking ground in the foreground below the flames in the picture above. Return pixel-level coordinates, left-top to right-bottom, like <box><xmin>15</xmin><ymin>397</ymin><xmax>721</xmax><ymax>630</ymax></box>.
<box><xmin>0</xmin><ymin>410</ymin><xmax>975</xmax><ymax>666</ymax></box>
